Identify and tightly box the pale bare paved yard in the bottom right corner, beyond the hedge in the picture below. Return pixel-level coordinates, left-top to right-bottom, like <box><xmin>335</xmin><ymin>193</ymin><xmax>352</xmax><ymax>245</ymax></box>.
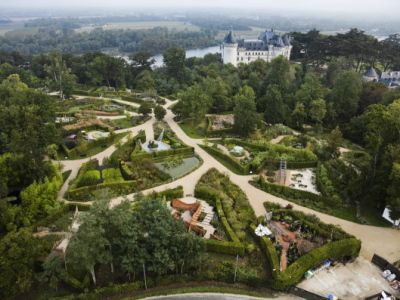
<box><xmin>298</xmin><ymin>257</ymin><xmax>400</xmax><ymax>300</ymax></box>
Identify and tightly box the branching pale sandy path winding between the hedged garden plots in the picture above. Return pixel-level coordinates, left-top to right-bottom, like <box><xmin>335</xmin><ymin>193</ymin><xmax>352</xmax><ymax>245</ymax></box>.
<box><xmin>60</xmin><ymin>99</ymin><xmax>400</xmax><ymax>262</ymax></box>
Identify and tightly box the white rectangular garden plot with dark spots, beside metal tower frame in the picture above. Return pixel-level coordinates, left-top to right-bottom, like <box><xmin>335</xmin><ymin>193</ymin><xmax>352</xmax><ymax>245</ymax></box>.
<box><xmin>285</xmin><ymin>168</ymin><xmax>320</xmax><ymax>195</ymax></box>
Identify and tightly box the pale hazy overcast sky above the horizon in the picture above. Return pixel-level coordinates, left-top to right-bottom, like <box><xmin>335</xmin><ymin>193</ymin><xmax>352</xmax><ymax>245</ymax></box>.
<box><xmin>0</xmin><ymin>0</ymin><xmax>400</xmax><ymax>18</ymax></box>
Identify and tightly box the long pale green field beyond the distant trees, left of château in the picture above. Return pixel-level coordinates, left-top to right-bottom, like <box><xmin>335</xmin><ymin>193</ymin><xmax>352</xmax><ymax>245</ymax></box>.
<box><xmin>76</xmin><ymin>21</ymin><xmax>200</xmax><ymax>32</ymax></box>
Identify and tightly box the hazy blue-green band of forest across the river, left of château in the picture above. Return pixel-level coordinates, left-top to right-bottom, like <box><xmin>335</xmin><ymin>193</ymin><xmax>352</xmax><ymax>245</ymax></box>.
<box><xmin>0</xmin><ymin>26</ymin><xmax>216</xmax><ymax>55</ymax></box>
